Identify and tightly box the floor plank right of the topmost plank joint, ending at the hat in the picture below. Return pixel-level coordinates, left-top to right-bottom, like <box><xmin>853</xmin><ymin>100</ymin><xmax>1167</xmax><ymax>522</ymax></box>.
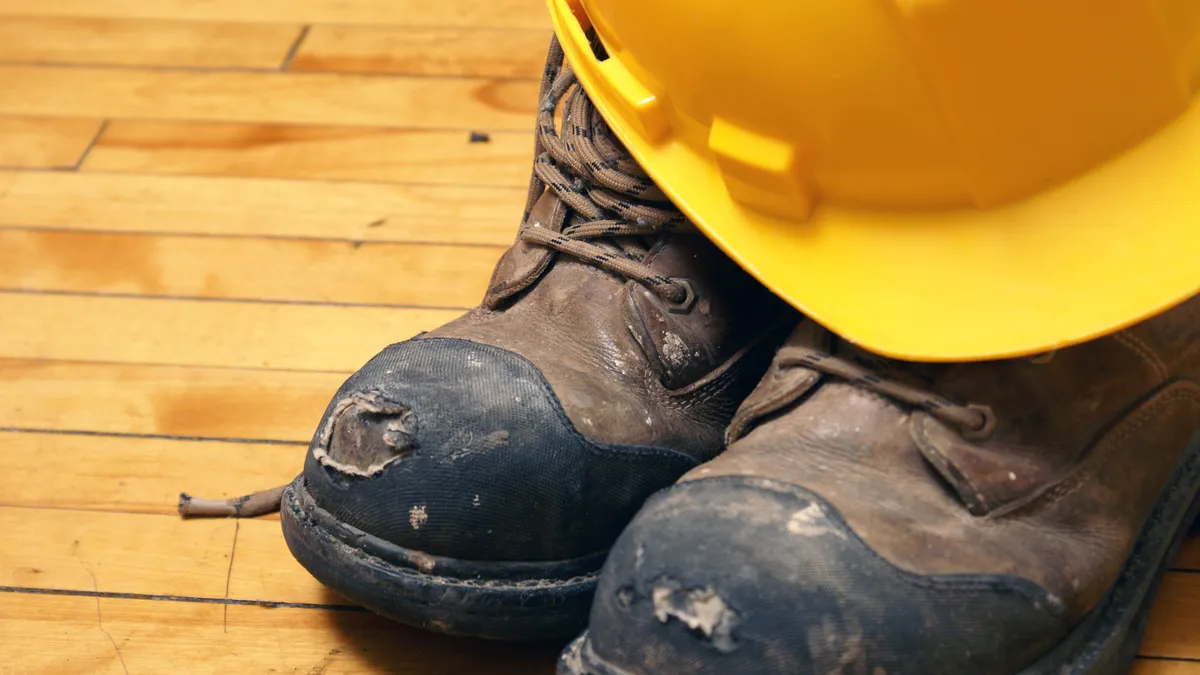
<box><xmin>289</xmin><ymin>25</ymin><xmax>550</xmax><ymax>79</ymax></box>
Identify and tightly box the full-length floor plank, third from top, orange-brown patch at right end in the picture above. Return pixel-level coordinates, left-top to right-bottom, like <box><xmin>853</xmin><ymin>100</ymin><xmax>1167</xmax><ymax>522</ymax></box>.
<box><xmin>0</xmin><ymin>65</ymin><xmax>538</xmax><ymax>131</ymax></box>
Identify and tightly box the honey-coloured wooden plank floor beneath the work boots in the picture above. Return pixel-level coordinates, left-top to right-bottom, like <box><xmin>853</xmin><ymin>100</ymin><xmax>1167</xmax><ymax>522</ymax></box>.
<box><xmin>0</xmin><ymin>0</ymin><xmax>1200</xmax><ymax>675</ymax></box>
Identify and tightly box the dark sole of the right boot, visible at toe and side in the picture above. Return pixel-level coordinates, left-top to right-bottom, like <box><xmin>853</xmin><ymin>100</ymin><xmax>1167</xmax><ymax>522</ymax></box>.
<box><xmin>558</xmin><ymin>430</ymin><xmax>1200</xmax><ymax>675</ymax></box>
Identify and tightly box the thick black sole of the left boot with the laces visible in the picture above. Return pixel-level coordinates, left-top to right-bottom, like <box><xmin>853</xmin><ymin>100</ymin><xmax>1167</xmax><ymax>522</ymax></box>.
<box><xmin>280</xmin><ymin>477</ymin><xmax>606</xmax><ymax>641</ymax></box>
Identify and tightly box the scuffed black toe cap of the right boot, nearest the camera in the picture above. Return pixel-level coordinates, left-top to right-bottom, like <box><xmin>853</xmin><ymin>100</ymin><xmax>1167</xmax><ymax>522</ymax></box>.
<box><xmin>582</xmin><ymin>477</ymin><xmax>1068</xmax><ymax>675</ymax></box>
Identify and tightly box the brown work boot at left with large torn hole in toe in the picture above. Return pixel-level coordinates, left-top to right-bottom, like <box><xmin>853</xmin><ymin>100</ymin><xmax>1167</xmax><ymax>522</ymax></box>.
<box><xmin>282</xmin><ymin>38</ymin><xmax>796</xmax><ymax>639</ymax></box>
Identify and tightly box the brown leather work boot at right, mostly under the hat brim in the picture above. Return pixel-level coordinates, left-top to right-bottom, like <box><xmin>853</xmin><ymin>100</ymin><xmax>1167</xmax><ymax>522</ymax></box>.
<box><xmin>560</xmin><ymin>297</ymin><xmax>1200</xmax><ymax>675</ymax></box>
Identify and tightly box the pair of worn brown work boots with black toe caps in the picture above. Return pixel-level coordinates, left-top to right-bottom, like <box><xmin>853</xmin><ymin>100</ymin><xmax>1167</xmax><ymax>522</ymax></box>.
<box><xmin>282</xmin><ymin>43</ymin><xmax>1200</xmax><ymax>675</ymax></box>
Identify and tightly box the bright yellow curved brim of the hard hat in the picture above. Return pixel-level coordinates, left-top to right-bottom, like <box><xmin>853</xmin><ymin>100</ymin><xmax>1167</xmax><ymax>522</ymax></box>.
<box><xmin>551</xmin><ymin>0</ymin><xmax>1200</xmax><ymax>362</ymax></box>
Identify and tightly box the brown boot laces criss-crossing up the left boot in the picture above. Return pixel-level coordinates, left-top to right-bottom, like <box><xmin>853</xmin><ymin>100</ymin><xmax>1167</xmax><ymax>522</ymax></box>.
<box><xmin>520</xmin><ymin>38</ymin><xmax>696</xmax><ymax>304</ymax></box>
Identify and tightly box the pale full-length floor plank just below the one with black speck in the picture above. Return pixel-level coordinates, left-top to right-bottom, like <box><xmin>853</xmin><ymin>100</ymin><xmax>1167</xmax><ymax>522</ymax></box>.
<box><xmin>0</xmin><ymin>171</ymin><xmax>526</xmax><ymax>246</ymax></box>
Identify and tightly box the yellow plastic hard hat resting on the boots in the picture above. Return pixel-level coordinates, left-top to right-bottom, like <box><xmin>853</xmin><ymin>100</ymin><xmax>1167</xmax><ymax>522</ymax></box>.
<box><xmin>548</xmin><ymin>0</ymin><xmax>1200</xmax><ymax>360</ymax></box>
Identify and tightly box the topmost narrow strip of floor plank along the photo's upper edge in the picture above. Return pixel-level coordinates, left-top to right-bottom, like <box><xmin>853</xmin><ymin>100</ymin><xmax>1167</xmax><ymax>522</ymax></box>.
<box><xmin>0</xmin><ymin>0</ymin><xmax>550</xmax><ymax>30</ymax></box>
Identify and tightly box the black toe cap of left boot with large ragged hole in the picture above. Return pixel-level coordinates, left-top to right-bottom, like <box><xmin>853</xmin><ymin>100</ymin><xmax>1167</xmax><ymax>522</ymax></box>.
<box><xmin>304</xmin><ymin>339</ymin><xmax>696</xmax><ymax>561</ymax></box>
